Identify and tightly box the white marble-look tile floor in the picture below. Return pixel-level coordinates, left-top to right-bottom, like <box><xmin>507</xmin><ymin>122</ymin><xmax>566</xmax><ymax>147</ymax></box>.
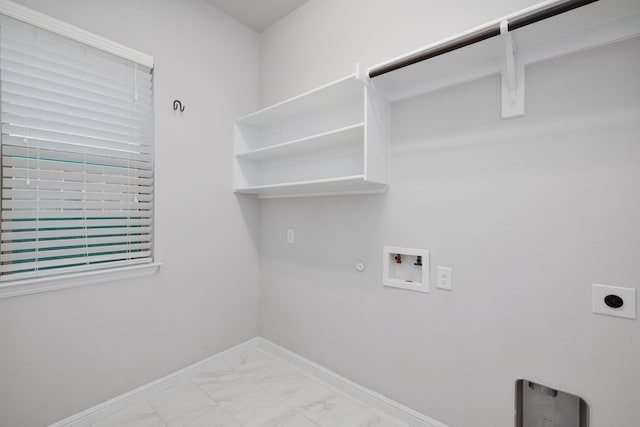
<box><xmin>91</xmin><ymin>349</ymin><xmax>409</xmax><ymax>427</ymax></box>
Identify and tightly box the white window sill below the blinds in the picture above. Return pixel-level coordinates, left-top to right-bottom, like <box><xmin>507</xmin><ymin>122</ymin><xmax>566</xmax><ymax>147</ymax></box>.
<box><xmin>0</xmin><ymin>262</ymin><xmax>162</xmax><ymax>299</ymax></box>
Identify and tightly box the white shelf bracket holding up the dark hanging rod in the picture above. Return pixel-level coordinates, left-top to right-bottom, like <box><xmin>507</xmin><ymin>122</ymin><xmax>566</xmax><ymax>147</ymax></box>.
<box><xmin>500</xmin><ymin>21</ymin><xmax>524</xmax><ymax>119</ymax></box>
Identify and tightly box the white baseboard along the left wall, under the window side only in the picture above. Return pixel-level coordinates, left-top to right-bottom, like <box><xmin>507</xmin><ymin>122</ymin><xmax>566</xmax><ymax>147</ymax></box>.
<box><xmin>49</xmin><ymin>338</ymin><xmax>259</xmax><ymax>427</ymax></box>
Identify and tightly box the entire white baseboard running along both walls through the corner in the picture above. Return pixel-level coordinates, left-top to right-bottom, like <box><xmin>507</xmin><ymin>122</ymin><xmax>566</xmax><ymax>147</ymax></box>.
<box><xmin>49</xmin><ymin>337</ymin><xmax>448</xmax><ymax>427</ymax></box>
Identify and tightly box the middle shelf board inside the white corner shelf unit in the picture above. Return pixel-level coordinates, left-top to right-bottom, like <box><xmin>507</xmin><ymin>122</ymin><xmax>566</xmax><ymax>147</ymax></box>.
<box><xmin>236</xmin><ymin>122</ymin><xmax>364</xmax><ymax>160</ymax></box>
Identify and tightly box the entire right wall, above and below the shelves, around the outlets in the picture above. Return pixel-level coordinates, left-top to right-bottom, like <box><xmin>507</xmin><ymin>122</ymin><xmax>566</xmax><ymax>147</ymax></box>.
<box><xmin>260</xmin><ymin>0</ymin><xmax>640</xmax><ymax>427</ymax></box>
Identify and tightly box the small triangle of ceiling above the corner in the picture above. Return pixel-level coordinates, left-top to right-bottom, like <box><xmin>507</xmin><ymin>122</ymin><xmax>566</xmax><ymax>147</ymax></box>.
<box><xmin>209</xmin><ymin>0</ymin><xmax>308</xmax><ymax>33</ymax></box>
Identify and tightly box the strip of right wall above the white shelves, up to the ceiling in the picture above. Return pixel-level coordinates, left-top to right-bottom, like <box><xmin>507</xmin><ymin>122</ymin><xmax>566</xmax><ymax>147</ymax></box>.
<box><xmin>261</xmin><ymin>0</ymin><xmax>539</xmax><ymax>105</ymax></box>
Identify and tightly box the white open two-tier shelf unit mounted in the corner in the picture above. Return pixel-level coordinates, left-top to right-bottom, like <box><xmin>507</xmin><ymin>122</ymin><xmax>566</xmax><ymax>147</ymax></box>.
<box><xmin>234</xmin><ymin>69</ymin><xmax>389</xmax><ymax>197</ymax></box>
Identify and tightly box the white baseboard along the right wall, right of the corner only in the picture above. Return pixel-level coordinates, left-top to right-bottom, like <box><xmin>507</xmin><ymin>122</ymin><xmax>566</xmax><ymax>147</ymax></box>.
<box><xmin>257</xmin><ymin>337</ymin><xmax>448</xmax><ymax>427</ymax></box>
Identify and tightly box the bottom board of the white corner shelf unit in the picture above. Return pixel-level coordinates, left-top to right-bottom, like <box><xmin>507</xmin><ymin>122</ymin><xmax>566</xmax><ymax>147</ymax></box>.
<box><xmin>235</xmin><ymin>175</ymin><xmax>387</xmax><ymax>199</ymax></box>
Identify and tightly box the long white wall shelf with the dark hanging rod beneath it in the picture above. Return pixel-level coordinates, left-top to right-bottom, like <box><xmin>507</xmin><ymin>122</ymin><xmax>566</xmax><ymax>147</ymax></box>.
<box><xmin>369</xmin><ymin>0</ymin><xmax>640</xmax><ymax>106</ymax></box>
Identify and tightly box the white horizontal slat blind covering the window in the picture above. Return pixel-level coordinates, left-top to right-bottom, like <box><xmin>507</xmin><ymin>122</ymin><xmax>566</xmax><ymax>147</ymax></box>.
<box><xmin>0</xmin><ymin>15</ymin><xmax>153</xmax><ymax>282</ymax></box>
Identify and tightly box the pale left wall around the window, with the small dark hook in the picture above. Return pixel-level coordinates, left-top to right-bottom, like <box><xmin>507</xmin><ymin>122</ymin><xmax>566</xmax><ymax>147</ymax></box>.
<box><xmin>0</xmin><ymin>0</ymin><xmax>259</xmax><ymax>427</ymax></box>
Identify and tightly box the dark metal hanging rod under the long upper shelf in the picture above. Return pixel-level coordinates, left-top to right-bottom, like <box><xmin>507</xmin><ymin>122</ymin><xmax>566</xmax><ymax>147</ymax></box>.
<box><xmin>369</xmin><ymin>0</ymin><xmax>599</xmax><ymax>78</ymax></box>
